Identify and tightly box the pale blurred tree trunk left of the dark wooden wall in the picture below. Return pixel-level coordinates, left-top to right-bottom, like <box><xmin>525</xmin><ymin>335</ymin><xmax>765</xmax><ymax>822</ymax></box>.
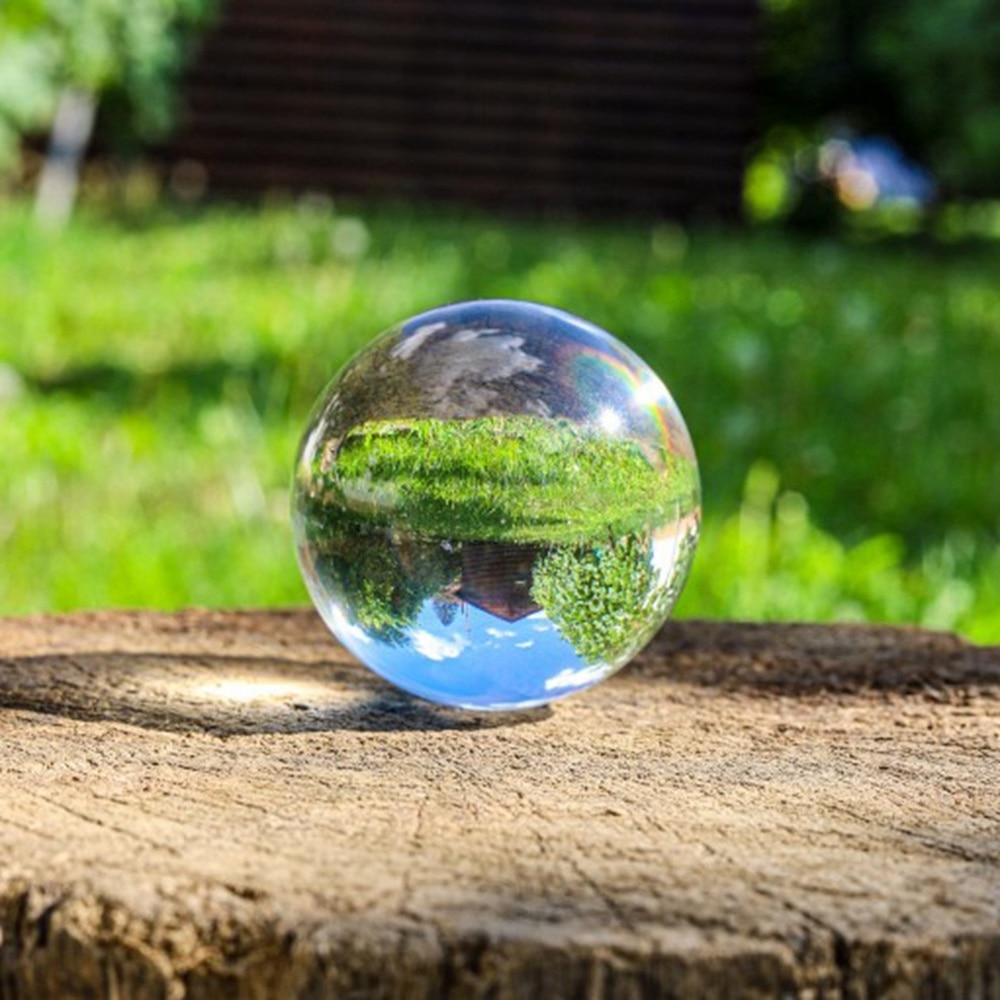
<box><xmin>35</xmin><ymin>87</ymin><xmax>97</xmax><ymax>229</ymax></box>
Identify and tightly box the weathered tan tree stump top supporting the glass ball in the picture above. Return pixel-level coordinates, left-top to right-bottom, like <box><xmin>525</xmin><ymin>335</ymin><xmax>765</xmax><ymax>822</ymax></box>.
<box><xmin>0</xmin><ymin>612</ymin><xmax>1000</xmax><ymax>1000</ymax></box>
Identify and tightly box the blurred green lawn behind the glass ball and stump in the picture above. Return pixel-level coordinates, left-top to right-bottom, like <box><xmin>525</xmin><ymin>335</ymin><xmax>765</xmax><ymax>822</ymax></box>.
<box><xmin>0</xmin><ymin>198</ymin><xmax>1000</xmax><ymax>641</ymax></box>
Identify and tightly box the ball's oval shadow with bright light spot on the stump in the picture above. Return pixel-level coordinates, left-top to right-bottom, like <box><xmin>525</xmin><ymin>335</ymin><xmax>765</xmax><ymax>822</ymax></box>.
<box><xmin>0</xmin><ymin>651</ymin><xmax>551</xmax><ymax>736</ymax></box>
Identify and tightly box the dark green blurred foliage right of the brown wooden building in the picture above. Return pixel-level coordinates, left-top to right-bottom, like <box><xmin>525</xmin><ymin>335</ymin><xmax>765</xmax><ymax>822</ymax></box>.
<box><xmin>756</xmin><ymin>0</ymin><xmax>1000</xmax><ymax>205</ymax></box>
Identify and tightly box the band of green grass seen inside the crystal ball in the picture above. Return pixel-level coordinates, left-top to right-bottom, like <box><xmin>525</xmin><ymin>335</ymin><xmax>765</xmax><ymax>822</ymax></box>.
<box><xmin>301</xmin><ymin>415</ymin><xmax>697</xmax><ymax>544</ymax></box>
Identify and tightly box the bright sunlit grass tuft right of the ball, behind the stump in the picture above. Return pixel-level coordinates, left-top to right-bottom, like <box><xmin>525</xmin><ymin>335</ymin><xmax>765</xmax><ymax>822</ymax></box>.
<box><xmin>678</xmin><ymin>462</ymin><xmax>1000</xmax><ymax>642</ymax></box>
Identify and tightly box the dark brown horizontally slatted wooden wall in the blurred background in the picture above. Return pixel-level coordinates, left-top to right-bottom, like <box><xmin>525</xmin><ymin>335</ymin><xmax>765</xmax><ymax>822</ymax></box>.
<box><xmin>170</xmin><ymin>0</ymin><xmax>756</xmax><ymax>218</ymax></box>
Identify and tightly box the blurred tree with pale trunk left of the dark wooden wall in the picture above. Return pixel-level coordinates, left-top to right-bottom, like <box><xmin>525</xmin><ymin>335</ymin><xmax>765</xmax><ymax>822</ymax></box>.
<box><xmin>0</xmin><ymin>0</ymin><xmax>215</xmax><ymax>225</ymax></box>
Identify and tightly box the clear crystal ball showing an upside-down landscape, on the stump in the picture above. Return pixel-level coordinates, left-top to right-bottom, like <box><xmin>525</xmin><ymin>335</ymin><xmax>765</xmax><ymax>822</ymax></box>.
<box><xmin>292</xmin><ymin>300</ymin><xmax>701</xmax><ymax>709</ymax></box>
